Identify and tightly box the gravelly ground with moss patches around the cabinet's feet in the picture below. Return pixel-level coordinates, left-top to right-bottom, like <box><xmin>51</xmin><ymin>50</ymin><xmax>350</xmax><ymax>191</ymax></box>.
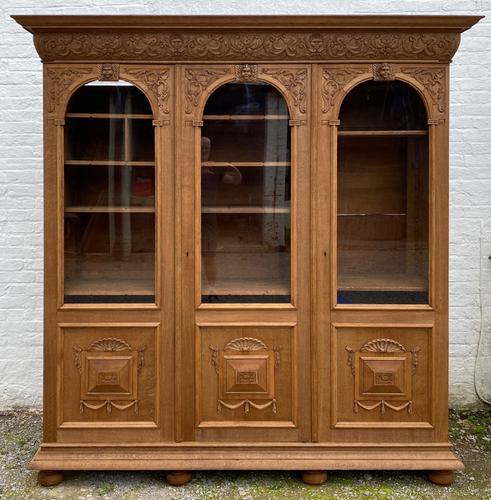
<box><xmin>0</xmin><ymin>409</ymin><xmax>491</xmax><ymax>500</ymax></box>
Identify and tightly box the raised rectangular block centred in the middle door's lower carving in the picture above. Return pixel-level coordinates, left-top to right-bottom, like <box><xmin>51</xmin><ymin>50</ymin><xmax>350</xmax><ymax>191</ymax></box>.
<box><xmin>219</xmin><ymin>351</ymin><xmax>274</xmax><ymax>399</ymax></box>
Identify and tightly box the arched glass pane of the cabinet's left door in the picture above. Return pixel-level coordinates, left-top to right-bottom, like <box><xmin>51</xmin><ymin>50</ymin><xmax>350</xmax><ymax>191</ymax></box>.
<box><xmin>64</xmin><ymin>82</ymin><xmax>155</xmax><ymax>303</ymax></box>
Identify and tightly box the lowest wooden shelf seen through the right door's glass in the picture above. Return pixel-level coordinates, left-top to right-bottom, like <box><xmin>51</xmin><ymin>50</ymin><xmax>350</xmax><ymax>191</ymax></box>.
<box><xmin>338</xmin><ymin>274</ymin><xmax>428</xmax><ymax>292</ymax></box>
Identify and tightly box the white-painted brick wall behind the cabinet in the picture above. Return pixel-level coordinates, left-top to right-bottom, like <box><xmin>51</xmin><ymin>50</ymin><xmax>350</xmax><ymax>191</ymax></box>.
<box><xmin>0</xmin><ymin>0</ymin><xmax>491</xmax><ymax>409</ymax></box>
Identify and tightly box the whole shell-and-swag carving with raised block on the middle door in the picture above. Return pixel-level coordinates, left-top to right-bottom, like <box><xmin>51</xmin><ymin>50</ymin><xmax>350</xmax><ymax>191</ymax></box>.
<box><xmin>209</xmin><ymin>337</ymin><xmax>281</xmax><ymax>415</ymax></box>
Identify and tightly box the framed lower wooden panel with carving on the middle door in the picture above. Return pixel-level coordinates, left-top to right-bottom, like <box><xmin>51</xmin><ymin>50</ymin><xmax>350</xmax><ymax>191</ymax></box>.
<box><xmin>196</xmin><ymin>323</ymin><xmax>297</xmax><ymax>441</ymax></box>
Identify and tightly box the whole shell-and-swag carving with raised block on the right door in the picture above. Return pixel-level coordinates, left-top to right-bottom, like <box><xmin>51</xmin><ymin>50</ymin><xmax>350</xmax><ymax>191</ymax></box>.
<box><xmin>346</xmin><ymin>338</ymin><xmax>420</xmax><ymax>414</ymax></box>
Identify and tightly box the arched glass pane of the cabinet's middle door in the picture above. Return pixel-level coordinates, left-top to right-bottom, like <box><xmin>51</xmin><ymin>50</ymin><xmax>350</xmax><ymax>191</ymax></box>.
<box><xmin>201</xmin><ymin>84</ymin><xmax>291</xmax><ymax>303</ymax></box>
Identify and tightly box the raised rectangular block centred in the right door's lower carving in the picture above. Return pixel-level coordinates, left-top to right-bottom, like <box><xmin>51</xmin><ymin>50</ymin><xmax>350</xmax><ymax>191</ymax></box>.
<box><xmin>355</xmin><ymin>352</ymin><xmax>411</xmax><ymax>400</ymax></box>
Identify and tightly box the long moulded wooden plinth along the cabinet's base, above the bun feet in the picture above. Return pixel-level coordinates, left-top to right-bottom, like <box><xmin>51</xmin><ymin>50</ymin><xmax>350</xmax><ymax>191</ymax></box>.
<box><xmin>29</xmin><ymin>443</ymin><xmax>464</xmax><ymax>470</ymax></box>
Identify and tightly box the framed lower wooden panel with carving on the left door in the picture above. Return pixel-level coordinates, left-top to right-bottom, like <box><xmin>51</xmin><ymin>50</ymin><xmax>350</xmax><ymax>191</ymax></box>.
<box><xmin>58</xmin><ymin>323</ymin><xmax>161</xmax><ymax>441</ymax></box>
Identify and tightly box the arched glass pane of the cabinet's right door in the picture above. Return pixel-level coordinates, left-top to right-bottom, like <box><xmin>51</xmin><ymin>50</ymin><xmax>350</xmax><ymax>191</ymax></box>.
<box><xmin>337</xmin><ymin>82</ymin><xmax>429</xmax><ymax>304</ymax></box>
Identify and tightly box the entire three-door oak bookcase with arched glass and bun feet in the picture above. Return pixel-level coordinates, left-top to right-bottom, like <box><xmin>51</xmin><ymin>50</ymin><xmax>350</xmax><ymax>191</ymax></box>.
<box><xmin>14</xmin><ymin>16</ymin><xmax>480</xmax><ymax>485</ymax></box>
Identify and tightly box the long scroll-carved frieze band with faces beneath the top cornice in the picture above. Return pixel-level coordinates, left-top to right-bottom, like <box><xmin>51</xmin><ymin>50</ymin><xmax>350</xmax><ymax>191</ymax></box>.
<box><xmin>34</xmin><ymin>29</ymin><xmax>460</xmax><ymax>61</ymax></box>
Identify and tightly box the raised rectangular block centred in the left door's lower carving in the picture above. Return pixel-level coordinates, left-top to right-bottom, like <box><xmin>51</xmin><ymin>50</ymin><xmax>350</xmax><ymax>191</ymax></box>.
<box><xmin>81</xmin><ymin>352</ymin><xmax>138</xmax><ymax>400</ymax></box>
